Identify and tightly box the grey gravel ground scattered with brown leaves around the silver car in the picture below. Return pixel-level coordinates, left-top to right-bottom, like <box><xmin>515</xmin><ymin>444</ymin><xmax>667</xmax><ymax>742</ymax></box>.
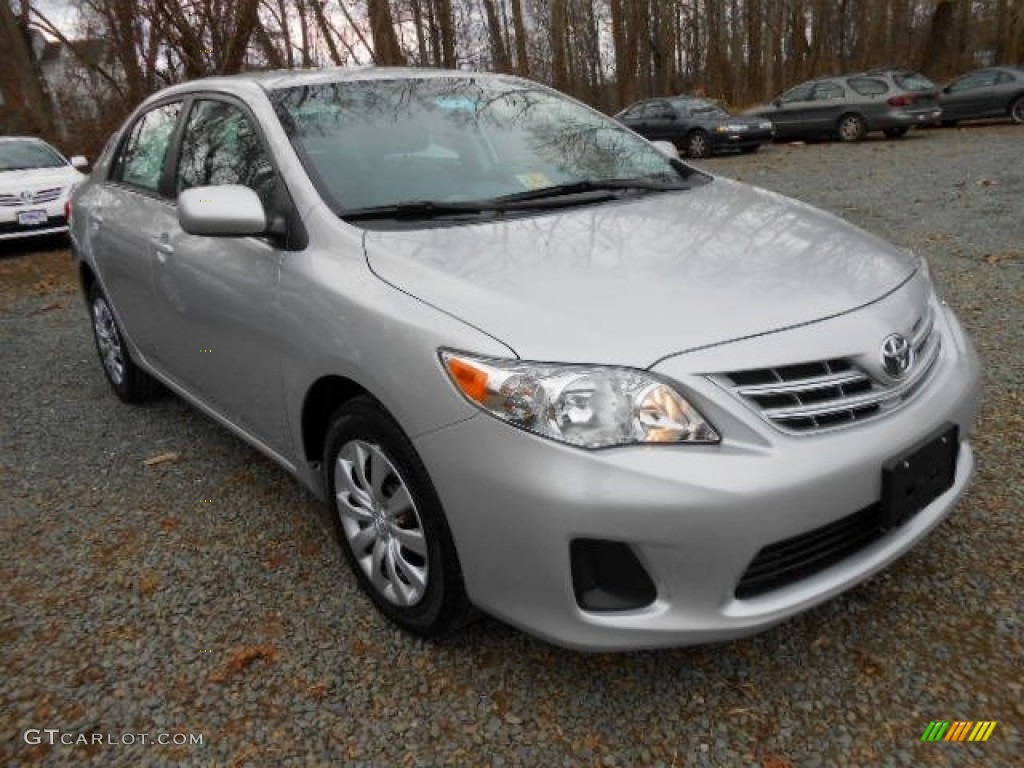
<box><xmin>0</xmin><ymin>126</ymin><xmax>1024</xmax><ymax>768</ymax></box>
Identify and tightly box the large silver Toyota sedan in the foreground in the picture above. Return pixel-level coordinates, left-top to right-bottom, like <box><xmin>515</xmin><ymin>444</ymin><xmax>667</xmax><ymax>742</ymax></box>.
<box><xmin>72</xmin><ymin>69</ymin><xmax>979</xmax><ymax>649</ymax></box>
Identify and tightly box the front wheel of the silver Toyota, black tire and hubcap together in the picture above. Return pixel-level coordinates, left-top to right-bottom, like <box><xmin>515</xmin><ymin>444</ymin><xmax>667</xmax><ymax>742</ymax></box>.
<box><xmin>324</xmin><ymin>396</ymin><xmax>473</xmax><ymax>638</ymax></box>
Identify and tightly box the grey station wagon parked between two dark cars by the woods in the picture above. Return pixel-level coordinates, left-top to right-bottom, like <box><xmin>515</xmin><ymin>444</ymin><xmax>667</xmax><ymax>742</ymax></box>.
<box><xmin>744</xmin><ymin>70</ymin><xmax>940</xmax><ymax>141</ymax></box>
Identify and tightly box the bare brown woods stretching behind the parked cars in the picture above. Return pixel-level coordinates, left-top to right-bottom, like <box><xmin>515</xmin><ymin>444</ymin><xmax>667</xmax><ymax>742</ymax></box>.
<box><xmin>0</xmin><ymin>0</ymin><xmax>1024</xmax><ymax>148</ymax></box>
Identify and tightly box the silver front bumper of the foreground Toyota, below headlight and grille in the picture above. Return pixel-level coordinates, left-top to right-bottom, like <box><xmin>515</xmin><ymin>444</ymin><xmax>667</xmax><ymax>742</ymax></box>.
<box><xmin>416</xmin><ymin>301</ymin><xmax>980</xmax><ymax>650</ymax></box>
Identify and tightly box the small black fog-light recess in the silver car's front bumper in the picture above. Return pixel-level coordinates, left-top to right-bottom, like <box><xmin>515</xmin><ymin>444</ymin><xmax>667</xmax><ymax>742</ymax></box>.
<box><xmin>569</xmin><ymin>539</ymin><xmax>657</xmax><ymax>611</ymax></box>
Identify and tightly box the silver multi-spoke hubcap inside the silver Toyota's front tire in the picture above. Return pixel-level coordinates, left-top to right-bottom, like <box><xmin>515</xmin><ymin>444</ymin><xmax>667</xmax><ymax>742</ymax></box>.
<box><xmin>334</xmin><ymin>440</ymin><xmax>429</xmax><ymax>607</ymax></box>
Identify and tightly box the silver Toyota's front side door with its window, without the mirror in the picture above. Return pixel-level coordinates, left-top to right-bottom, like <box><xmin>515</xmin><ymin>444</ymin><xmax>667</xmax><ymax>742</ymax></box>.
<box><xmin>153</xmin><ymin>95</ymin><xmax>291</xmax><ymax>456</ymax></box>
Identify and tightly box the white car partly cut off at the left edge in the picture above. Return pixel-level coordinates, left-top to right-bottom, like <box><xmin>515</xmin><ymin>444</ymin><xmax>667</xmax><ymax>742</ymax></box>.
<box><xmin>0</xmin><ymin>136</ymin><xmax>87</xmax><ymax>241</ymax></box>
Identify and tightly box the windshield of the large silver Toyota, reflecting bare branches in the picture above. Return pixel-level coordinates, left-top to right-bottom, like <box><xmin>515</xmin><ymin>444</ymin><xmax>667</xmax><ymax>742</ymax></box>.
<box><xmin>271</xmin><ymin>76</ymin><xmax>704</xmax><ymax>213</ymax></box>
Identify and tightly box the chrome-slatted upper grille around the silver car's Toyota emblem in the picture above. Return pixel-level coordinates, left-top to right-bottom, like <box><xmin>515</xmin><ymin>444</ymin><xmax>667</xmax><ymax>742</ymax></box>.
<box><xmin>712</xmin><ymin>308</ymin><xmax>941</xmax><ymax>434</ymax></box>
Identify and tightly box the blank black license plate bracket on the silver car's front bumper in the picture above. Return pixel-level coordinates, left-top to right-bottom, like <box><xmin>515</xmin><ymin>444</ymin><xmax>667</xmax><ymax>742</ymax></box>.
<box><xmin>882</xmin><ymin>423</ymin><xmax>959</xmax><ymax>528</ymax></box>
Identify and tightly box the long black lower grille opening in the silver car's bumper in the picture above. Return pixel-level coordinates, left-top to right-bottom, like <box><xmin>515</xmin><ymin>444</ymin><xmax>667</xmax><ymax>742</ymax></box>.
<box><xmin>736</xmin><ymin>502</ymin><xmax>886</xmax><ymax>599</ymax></box>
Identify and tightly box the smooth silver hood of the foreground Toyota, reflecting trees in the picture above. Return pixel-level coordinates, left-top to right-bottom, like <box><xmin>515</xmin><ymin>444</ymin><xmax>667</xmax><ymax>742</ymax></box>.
<box><xmin>365</xmin><ymin>179</ymin><xmax>914</xmax><ymax>368</ymax></box>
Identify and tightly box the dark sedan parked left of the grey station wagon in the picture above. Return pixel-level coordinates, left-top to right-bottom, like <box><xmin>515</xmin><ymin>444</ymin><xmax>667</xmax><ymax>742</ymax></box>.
<box><xmin>615</xmin><ymin>96</ymin><xmax>772</xmax><ymax>158</ymax></box>
